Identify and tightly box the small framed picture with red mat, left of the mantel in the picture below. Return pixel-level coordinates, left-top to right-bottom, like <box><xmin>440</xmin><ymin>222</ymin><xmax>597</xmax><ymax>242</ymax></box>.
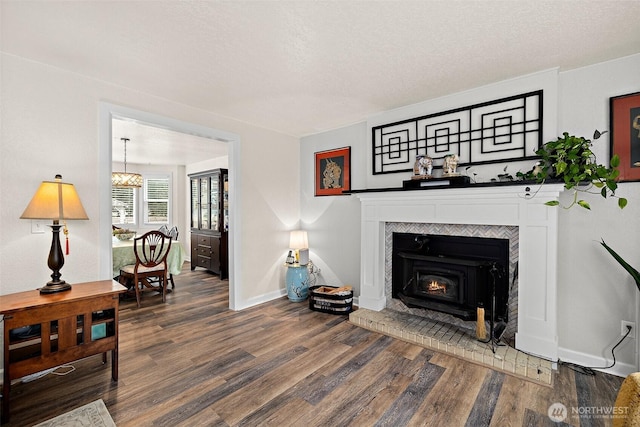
<box><xmin>315</xmin><ymin>147</ymin><xmax>351</xmax><ymax>196</ymax></box>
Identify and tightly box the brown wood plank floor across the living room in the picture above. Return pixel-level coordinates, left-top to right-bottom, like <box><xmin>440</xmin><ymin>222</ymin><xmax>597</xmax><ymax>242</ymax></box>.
<box><xmin>3</xmin><ymin>264</ymin><xmax>622</xmax><ymax>427</ymax></box>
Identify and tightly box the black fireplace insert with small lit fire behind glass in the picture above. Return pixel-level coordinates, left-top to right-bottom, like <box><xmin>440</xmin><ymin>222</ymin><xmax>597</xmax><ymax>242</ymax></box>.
<box><xmin>392</xmin><ymin>233</ymin><xmax>509</xmax><ymax>322</ymax></box>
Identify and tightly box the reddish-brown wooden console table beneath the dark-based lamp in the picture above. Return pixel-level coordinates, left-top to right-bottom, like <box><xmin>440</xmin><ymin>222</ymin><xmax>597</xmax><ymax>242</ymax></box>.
<box><xmin>0</xmin><ymin>280</ymin><xmax>126</xmax><ymax>423</ymax></box>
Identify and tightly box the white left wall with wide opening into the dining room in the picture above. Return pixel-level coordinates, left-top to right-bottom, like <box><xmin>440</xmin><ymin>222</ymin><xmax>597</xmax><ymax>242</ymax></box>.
<box><xmin>0</xmin><ymin>54</ymin><xmax>300</xmax><ymax>308</ymax></box>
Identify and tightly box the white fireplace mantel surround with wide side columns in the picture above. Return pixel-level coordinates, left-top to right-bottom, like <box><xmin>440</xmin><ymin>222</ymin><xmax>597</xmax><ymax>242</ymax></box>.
<box><xmin>356</xmin><ymin>184</ymin><xmax>564</xmax><ymax>360</ymax></box>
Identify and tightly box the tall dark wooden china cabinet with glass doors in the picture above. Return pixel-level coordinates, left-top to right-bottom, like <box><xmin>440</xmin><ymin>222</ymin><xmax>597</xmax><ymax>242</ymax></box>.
<box><xmin>189</xmin><ymin>169</ymin><xmax>229</xmax><ymax>279</ymax></box>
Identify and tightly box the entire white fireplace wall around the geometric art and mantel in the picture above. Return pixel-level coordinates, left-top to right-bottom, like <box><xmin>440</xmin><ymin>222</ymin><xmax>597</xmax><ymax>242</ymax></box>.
<box><xmin>300</xmin><ymin>55</ymin><xmax>640</xmax><ymax>375</ymax></box>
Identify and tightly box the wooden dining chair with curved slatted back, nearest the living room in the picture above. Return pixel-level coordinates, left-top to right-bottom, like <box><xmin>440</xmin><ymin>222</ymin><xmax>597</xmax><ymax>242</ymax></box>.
<box><xmin>119</xmin><ymin>230</ymin><xmax>172</xmax><ymax>307</ymax></box>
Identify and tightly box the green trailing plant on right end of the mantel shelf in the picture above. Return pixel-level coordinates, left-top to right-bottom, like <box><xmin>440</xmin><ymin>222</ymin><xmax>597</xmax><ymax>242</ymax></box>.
<box><xmin>518</xmin><ymin>131</ymin><xmax>627</xmax><ymax>209</ymax></box>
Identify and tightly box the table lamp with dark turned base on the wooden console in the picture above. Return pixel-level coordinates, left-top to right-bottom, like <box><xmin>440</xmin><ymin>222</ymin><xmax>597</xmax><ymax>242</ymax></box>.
<box><xmin>20</xmin><ymin>175</ymin><xmax>89</xmax><ymax>294</ymax></box>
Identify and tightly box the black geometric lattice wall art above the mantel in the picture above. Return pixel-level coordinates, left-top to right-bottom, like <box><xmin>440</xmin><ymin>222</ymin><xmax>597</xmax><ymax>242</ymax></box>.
<box><xmin>372</xmin><ymin>90</ymin><xmax>543</xmax><ymax>175</ymax></box>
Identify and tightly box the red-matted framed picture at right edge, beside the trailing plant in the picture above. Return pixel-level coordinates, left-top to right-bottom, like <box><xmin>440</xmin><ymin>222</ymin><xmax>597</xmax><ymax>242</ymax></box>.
<box><xmin>609</xmin><ymin>92</ymin><xmax>640</xmax><ymax>181</ymax></box>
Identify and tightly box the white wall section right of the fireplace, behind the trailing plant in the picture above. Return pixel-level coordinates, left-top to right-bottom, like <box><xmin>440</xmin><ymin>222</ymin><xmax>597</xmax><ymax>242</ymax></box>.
<box><xmin>558</xmin><ymin>55</ymin><xmax>640</xmax><ymax>374</ymax></box>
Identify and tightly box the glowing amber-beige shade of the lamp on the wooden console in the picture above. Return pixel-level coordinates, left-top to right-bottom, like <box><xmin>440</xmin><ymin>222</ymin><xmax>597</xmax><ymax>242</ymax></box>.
<box><xmin>20</xmin><ymin>175</ymin><xmax>89</xmax><ymax>220</ymax></box>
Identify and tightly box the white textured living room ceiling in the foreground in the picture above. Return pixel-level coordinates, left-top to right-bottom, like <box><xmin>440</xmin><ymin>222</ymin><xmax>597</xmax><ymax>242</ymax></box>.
<box><xmin>1</xmin><ymin>0</ymin><xmax>640</xmax><ymax>144</ymax></box>
